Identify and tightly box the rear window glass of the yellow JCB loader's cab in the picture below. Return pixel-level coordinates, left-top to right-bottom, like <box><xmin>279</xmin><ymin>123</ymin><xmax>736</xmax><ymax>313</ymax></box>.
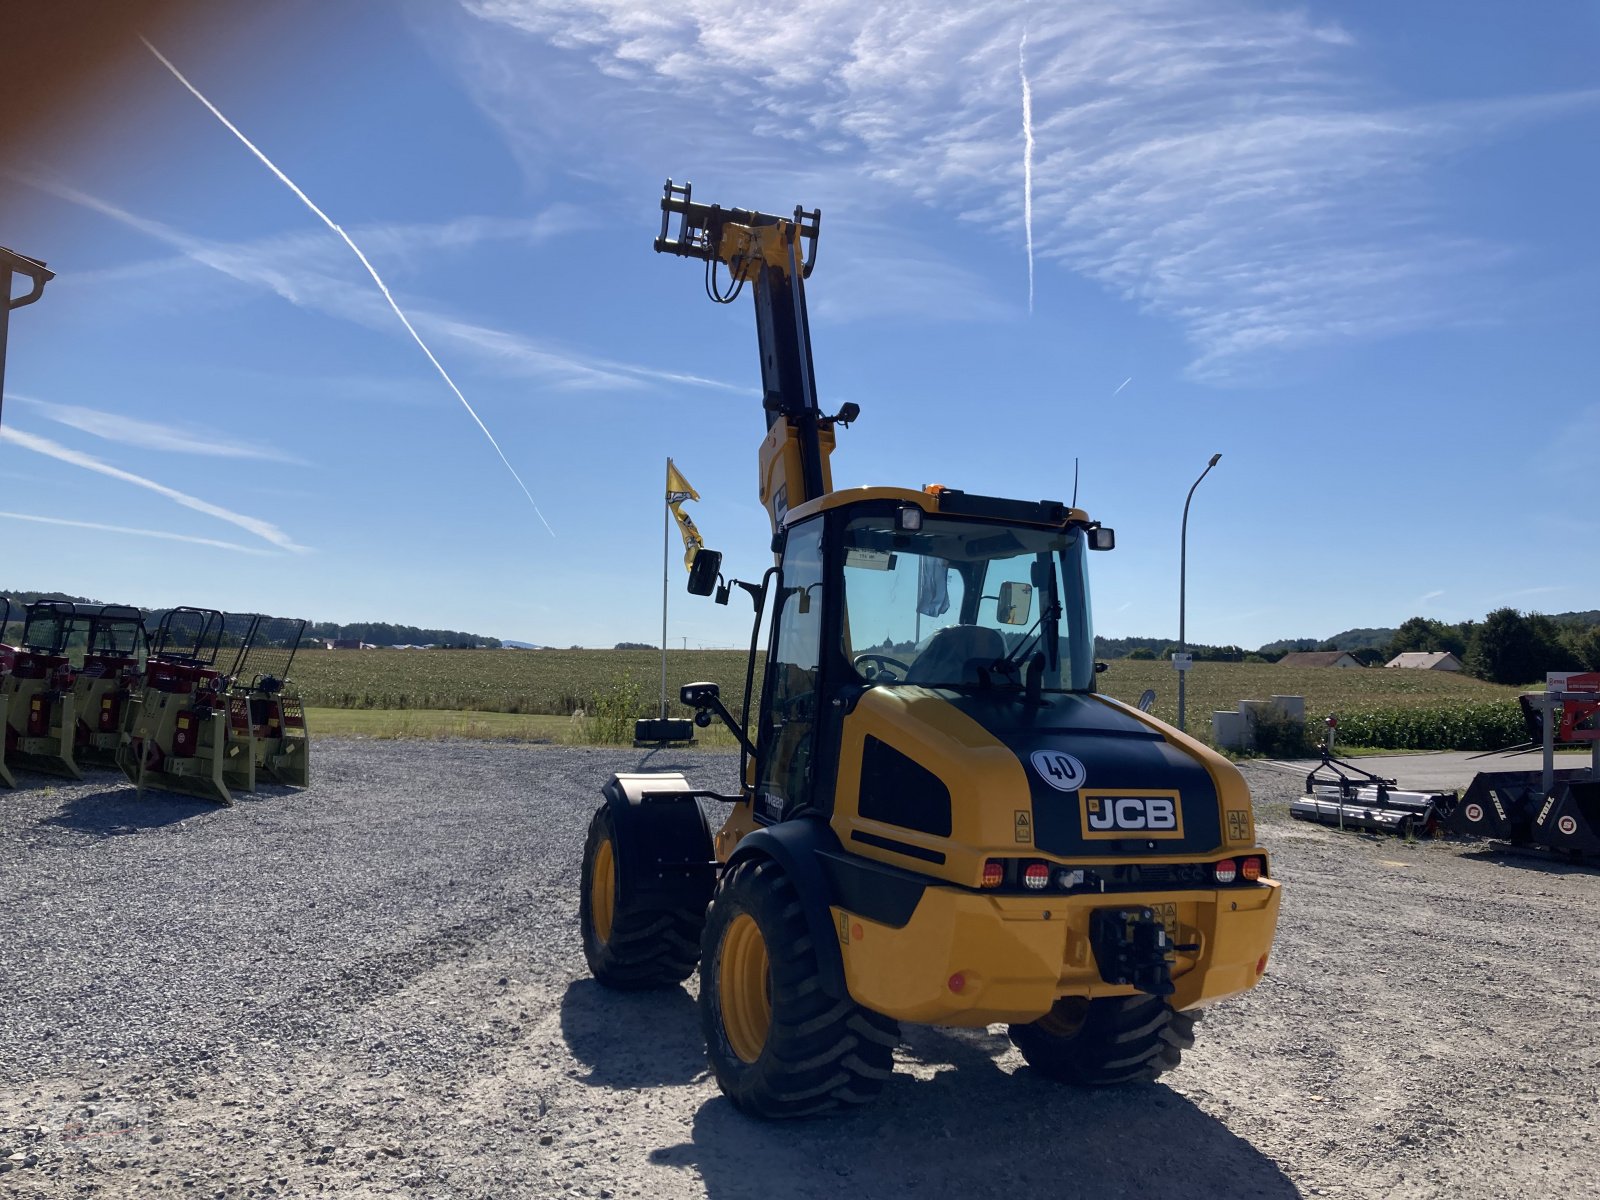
<box><xmin>843</xmin><ymin>514</ymin><xmax>1094</xmax><ymax>691</ymax></box>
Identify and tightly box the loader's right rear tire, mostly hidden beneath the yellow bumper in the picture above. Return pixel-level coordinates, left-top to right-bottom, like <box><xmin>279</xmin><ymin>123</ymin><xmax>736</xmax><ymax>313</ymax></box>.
<box><xmin>1010</xmin><ymin>995</ymin><xmax>1200</xmax><ymax>1086</ymax></box>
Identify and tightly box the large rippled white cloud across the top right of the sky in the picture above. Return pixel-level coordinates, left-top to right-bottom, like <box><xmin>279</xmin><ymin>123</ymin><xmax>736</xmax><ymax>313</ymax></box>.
<box><xmin>461</xmin><ymin>0</ymin><xmax>1600</xmax><ymax>378</ymax></box>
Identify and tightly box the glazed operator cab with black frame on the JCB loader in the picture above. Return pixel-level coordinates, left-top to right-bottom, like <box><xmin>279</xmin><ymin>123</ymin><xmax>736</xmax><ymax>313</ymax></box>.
<box><xmin>754</xmin><ymin>488</ymin><xmax>1114</xmax><ymax>822</ymax></box>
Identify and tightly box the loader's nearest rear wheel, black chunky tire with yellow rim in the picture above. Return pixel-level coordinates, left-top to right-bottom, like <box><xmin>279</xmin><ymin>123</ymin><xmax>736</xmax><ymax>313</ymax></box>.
<box><xmin>701</xmin><ymin>859</ymin><xmax>899</xmax><ymax>1117</ymax></box>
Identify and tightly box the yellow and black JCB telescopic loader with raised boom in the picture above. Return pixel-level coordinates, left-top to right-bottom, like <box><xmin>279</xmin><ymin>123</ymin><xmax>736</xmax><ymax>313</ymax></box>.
<box><xmin>579</xmin><ymin>182</ymin><xmax>1278</xmax><ymax>1117</ymax></box>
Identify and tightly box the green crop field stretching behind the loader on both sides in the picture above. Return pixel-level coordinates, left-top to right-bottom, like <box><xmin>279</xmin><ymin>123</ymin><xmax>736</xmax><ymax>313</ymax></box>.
<box><xmin>294</xmin><ymin>650</ymin><xmax>1517</xmax><ymax>744</ymax></box>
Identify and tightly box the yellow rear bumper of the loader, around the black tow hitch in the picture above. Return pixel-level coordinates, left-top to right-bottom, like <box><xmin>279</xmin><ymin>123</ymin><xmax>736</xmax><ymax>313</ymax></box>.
<box><xmin>832</xmin><ymin>880</ymin><xmax>1280</xmax><ymax>1026</ymax></box>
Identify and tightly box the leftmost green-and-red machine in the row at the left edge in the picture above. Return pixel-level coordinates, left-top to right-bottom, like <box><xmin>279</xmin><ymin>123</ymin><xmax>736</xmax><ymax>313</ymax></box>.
<box><xmin>0</xmin><ymin>600</ymin><xmax>88</xmax><ymax>787</ymax></box>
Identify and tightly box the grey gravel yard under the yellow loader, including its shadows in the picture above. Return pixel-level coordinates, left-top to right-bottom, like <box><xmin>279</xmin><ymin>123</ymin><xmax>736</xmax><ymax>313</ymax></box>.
<box><xmin>0</xmin><ymin>742</ymin><xmax>1600</xmax><ymax>1200</ymax></box>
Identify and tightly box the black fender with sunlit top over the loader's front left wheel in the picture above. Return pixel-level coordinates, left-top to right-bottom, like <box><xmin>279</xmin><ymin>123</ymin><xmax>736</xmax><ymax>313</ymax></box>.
<box><xmin>600</xmin><ymin>771</ymin><xmax>717</xmax><ymax>909</ymax></box>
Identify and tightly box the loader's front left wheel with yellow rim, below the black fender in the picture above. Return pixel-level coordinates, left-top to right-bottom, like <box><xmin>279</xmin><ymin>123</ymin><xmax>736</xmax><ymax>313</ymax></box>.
<box><xmin>578</xmin><ymin>805</ymin><xmax>706</xmax><ymax>992</ymax></box>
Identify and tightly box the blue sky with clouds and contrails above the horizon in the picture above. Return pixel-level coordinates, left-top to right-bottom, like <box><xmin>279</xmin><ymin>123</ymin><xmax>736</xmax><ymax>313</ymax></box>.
<box><xmin>0</xmin><ymin>0</ymin><xmax>1600</xmax><ymax>646</ymax></box>
